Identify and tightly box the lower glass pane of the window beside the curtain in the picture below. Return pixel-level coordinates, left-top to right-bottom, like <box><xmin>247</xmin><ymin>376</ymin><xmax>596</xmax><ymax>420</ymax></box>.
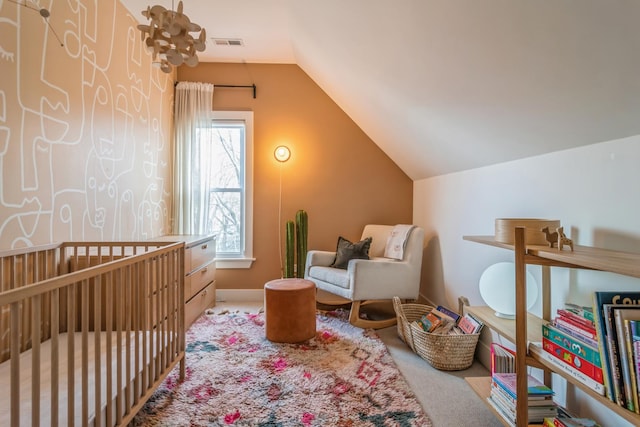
<box><xmin>209</xmin><ymin>191</ymin><xmax>243</xmax><ymax>254</ymax></box>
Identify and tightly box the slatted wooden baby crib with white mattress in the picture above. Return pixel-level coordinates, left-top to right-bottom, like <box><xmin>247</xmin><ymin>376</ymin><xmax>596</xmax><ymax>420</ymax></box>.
<box><xmin>0</xmin><ymin>242</ymin><xmax>185</xmax><ymax>426</ymax></box>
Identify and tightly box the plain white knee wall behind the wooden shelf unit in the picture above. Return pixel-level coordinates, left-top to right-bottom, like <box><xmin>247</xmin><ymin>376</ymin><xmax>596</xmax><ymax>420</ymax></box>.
<box><xmin>414</xmin><ymin>135</ymin><xmax>640</xmax><ymax>425</ymax></box>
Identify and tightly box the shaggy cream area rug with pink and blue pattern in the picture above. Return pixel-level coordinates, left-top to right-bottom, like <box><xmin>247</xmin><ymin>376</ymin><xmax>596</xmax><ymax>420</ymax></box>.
<box><xmin>133</xmin><ymin>312</ymin><xmax>431</xmax><ymax>427</ymax></box>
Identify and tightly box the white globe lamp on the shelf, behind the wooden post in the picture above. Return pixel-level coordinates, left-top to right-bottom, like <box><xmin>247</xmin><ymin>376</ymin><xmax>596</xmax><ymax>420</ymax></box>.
<box><xmin>479</xmin><ymin>262</ymin><xmax>538</xmax><ymax>319</ymax></box>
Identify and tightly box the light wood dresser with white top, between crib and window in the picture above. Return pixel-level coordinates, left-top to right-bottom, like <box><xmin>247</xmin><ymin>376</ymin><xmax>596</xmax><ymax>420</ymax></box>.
<box><xmin>151</xmin><ymin>234</ymin><xmax>216</xmax><ymax>328</ymax></box>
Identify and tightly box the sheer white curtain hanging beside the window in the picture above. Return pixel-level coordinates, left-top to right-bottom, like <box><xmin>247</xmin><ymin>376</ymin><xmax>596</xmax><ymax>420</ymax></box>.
<box><xmin>173</xmin><ymin>82</ymin><xmax>213</xmax><ymax>234</ymax></box>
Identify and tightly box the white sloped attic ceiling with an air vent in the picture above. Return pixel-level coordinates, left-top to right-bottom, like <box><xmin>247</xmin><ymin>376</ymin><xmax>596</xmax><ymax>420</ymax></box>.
<box><xmin>122</xmin><ymin>0</ymin><xmax>640</xmax><ymax>179</ymax></box>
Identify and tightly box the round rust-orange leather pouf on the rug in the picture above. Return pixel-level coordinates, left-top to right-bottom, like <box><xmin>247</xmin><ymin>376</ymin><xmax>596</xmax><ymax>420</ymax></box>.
<box><xmin>264</xmin><ymin>279</ymin><xmax>316</xmax><ymax>343</ymax></box>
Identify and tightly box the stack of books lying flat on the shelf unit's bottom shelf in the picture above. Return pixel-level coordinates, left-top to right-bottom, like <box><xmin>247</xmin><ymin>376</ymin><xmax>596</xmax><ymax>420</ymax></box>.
<box><xmin>487</xmin><ymin>372</ymin><xmax>558</xmax><ymax>425</ymax></box>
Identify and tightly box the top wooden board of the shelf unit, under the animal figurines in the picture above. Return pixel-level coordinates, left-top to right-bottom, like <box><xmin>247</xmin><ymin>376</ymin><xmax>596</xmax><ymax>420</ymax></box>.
<box><xmin>463</xmin><ymin>236</ymin><xmax>640</xmax><ymax>278</ymax></box>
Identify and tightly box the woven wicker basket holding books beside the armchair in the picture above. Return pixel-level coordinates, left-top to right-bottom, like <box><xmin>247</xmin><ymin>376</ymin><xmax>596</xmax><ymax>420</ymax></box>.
<box><xmin>393</xmin><ymin>297</ymin><xmax>480</xmax><ymax>371</ymax></box>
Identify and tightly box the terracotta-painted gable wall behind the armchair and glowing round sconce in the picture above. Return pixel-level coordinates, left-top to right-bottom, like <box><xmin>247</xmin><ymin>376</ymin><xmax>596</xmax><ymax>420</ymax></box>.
<box><xmin>178</xmin><ymin>63</ymin><xmax>413</xmax><ymax>289</ymax></box>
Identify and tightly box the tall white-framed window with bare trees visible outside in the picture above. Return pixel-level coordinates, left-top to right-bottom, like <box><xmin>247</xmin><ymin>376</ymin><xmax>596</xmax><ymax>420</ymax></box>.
<box><xmin>198</xmin><ymin>111</ymin><xmax>253</xmax><ymax>268</ymax></box>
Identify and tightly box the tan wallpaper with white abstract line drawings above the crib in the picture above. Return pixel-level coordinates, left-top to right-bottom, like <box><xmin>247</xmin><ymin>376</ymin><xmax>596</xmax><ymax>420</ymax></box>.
<box><xmin>0</xmin><ymin>0</ymin><xmax>175</xmax><ymax>249</ymax></box>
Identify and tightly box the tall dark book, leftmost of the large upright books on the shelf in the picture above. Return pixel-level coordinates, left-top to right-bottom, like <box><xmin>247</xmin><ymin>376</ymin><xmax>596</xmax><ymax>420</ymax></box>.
<box><xmin>592</xmin><ymin>291</ymin><xmax>640</xmax><ymax>402</ymax></box>
